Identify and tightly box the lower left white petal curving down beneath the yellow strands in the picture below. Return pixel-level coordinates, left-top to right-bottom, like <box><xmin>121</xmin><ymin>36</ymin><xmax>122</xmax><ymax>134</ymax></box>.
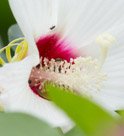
<box><xmin>0</xmin><ymin>57</ymin><xmax>72</xmax><ymax>131</ymax></box>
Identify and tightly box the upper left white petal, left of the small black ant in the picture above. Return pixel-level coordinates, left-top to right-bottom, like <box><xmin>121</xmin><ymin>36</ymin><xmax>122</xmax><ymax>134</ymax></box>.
<box><xmin>9</xmin><ymin>0</ymin><xmax>58</xmax><ymax>39</ymax></box>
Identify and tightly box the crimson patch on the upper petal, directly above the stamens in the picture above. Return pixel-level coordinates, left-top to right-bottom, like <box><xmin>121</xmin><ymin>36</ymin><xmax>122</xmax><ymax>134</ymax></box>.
<box><xmin>36</xmin><ymin>34</ymin><xmax>78</xmax><ymax>61</ymax></box>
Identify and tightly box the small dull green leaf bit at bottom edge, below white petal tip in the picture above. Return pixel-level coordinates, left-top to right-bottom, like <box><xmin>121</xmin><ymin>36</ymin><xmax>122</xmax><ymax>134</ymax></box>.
<box><xmin>65</xmin><ymin>127</ymin><xmax>86</xmax><ymax>136</ymax></box>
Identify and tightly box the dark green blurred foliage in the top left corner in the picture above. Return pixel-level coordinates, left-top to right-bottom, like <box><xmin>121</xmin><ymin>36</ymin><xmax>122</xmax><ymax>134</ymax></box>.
<box><xmin>0</xmin><ymin>0</ymin><xmax>16</xmax><ymax>45</ymax></box>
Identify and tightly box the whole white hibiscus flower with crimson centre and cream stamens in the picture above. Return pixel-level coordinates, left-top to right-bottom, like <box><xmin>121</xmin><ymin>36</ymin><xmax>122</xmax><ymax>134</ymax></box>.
<box><xmin>0</xmin><ymin>0</ymin><xmax>124</xmax><ymax>132</ymax></box>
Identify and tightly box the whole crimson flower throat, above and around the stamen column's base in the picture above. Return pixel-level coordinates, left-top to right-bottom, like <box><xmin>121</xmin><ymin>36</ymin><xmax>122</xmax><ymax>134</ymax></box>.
<box><xmin>29</xmin><ymin>34</ymin><xmax>78</xmax><ymax>99</ymax></box>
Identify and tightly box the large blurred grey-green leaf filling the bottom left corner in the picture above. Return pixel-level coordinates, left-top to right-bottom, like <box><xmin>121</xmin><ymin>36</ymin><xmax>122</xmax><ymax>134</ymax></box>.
<box><xmin>0</xmin><ymin>113</ymin><xmax>61</xmax><ymax>136</ymax></box>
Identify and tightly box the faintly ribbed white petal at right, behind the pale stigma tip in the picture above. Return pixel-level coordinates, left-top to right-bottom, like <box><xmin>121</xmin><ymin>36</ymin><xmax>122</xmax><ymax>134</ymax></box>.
<box><xmin>94</xmin><ymin>26</ymin><xmax>124</xmax><ymax>110</ymax></box>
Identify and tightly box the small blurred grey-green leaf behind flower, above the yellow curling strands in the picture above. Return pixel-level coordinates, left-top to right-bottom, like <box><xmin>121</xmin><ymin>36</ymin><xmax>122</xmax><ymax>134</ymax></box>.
<box><xmin>8</xmin><ymin>24</ymin><xmax>24</xmax><ymax>42</ymax></box>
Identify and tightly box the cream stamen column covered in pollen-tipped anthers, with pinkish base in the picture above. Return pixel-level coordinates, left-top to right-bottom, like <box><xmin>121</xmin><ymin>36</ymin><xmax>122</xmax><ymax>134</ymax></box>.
<box><xmin>29</xmin><ymin>57</ymin><xmax>106</xmax><ymax>98</ymax></box>
